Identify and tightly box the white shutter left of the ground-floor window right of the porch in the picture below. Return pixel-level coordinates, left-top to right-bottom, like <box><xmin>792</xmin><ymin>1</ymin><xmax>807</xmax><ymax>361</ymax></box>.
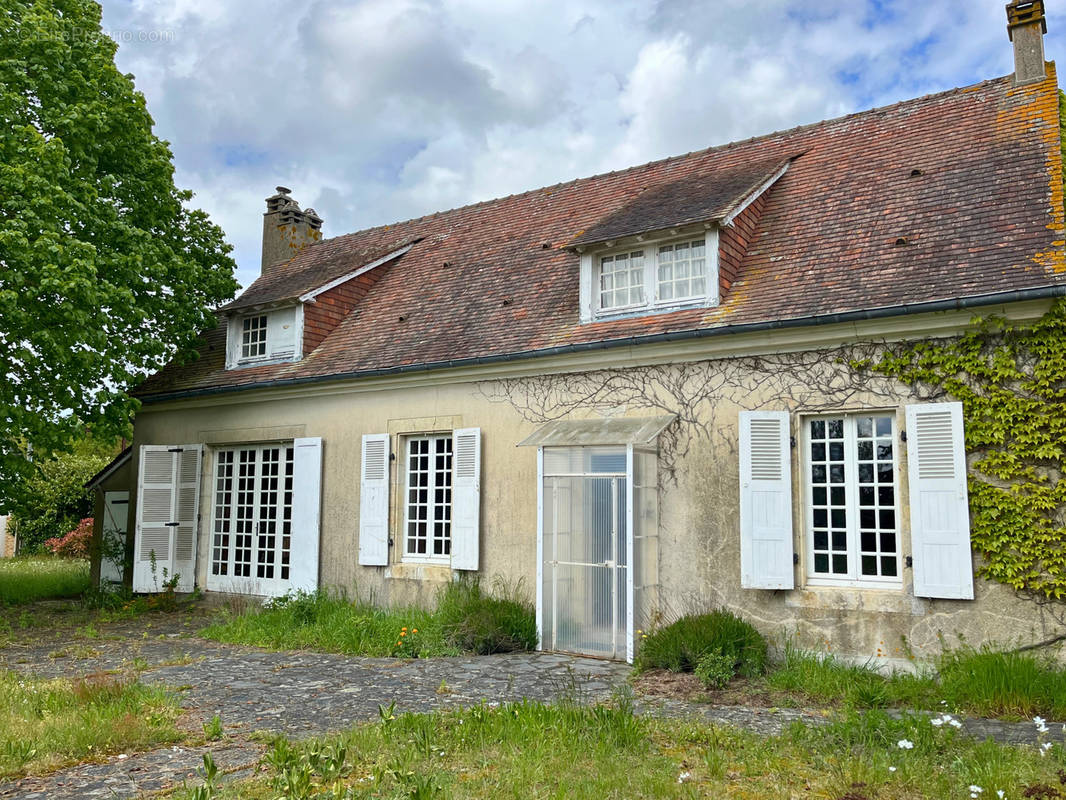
<box><xmin>740</xmin><ymin>411</ymin><xmax>795</xmax><ymax>589</ymax></box>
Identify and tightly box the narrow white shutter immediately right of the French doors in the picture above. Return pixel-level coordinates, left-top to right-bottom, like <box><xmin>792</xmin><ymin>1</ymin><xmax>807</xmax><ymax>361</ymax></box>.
<box><xmin>289</xmin><ymin>436</ymin><xmax>322</xmax><ymax>592</ymax></box>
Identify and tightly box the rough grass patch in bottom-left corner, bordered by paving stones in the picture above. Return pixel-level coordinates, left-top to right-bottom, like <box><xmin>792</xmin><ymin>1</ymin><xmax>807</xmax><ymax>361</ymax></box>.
<box><xmin>0</xmin><ymin>671</ymin><xmax>182</xmax><ymax>778</ymax></box>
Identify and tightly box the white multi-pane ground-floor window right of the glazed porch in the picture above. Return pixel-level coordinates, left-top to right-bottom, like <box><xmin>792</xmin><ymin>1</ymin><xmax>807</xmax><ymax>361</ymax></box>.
<box><xmin>806</xmin><ymin>414</ymin><xmax>900</xmax><ymax>583</ymax></box>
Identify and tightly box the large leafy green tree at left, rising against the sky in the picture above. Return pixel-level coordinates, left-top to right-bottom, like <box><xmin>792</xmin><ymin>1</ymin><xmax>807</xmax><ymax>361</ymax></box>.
<box><xmin>0</xmin><ymin>0</ymin><xmax>237</xmax><ymax>509</ymax></box>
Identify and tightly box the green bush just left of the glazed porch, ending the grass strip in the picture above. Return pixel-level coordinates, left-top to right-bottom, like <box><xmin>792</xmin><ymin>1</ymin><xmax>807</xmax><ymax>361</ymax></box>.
<box><xmin>437</xmin><ymin>579</ymin><xmax>536</xmax><ymax>655</ymax></box>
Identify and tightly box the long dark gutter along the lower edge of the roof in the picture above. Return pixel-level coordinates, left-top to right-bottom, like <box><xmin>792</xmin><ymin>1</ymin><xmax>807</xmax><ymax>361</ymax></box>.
<box><xmin>134</xmin><ymin>284</ymin><xmax>1066</xmax><ymax>405</ymax></box>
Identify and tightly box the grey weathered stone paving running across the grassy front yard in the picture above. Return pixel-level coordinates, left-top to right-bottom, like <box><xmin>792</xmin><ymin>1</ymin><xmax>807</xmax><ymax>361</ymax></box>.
<box><xmin>0</xmin><ymin>615</ymin><xmax>1061</xmax><ymax>800</ymax></box>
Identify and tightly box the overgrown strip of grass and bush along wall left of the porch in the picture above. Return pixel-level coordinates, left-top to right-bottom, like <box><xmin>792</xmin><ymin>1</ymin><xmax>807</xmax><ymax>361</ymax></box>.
<box><xmin>201</xmin><ymin>581</ymin><xmax>536</xmax><ymax>658</ymax></box>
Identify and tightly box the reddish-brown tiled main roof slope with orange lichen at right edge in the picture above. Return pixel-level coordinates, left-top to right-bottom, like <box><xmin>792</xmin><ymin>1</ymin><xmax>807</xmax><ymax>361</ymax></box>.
<box><xmin>138</xmin><ymin>69</ymin><xmax>1066</xmax><ymax>397</ymax></box>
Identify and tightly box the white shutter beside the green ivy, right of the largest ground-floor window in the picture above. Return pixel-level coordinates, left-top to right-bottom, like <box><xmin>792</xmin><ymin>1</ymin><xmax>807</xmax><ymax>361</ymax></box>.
<box><xmin>907</xmin><ymin>403</ymin><xmax>973</xmax><ymax>599</ymax></box>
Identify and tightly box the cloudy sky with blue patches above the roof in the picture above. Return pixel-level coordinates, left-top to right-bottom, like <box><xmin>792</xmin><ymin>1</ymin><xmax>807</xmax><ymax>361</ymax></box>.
<box><xmin>102</xmin><ymin>0</ymin><xmax>1066</xmax><ymax>286</ymax></box>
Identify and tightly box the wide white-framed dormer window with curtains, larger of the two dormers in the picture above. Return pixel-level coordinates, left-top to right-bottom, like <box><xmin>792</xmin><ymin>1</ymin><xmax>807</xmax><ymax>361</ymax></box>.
<box><xmin>591</xmin><ymin>236</ymin><xmax>717</xmax><ymax>316</ymax></box>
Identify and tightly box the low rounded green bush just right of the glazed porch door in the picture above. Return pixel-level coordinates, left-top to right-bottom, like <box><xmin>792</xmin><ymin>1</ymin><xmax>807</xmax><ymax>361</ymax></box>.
<box><xmin>635</xmin><ymin>610</ymin><xmax>766</xmax><ymax>677</ymax></box>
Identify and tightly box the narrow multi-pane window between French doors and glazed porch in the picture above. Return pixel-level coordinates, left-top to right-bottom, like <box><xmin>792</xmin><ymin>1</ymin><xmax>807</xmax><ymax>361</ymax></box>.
<box><xmin>404</xmin><ymin>435</ymin><xmax>452</xmax><ymax>561</ymax></box>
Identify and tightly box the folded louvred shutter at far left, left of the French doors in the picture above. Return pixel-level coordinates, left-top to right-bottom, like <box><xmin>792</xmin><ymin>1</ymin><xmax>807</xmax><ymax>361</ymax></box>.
<box><xmin>133</xmin><ymin>445</ymin><xmax>200</xmax><ymax>592</ymax></box>
